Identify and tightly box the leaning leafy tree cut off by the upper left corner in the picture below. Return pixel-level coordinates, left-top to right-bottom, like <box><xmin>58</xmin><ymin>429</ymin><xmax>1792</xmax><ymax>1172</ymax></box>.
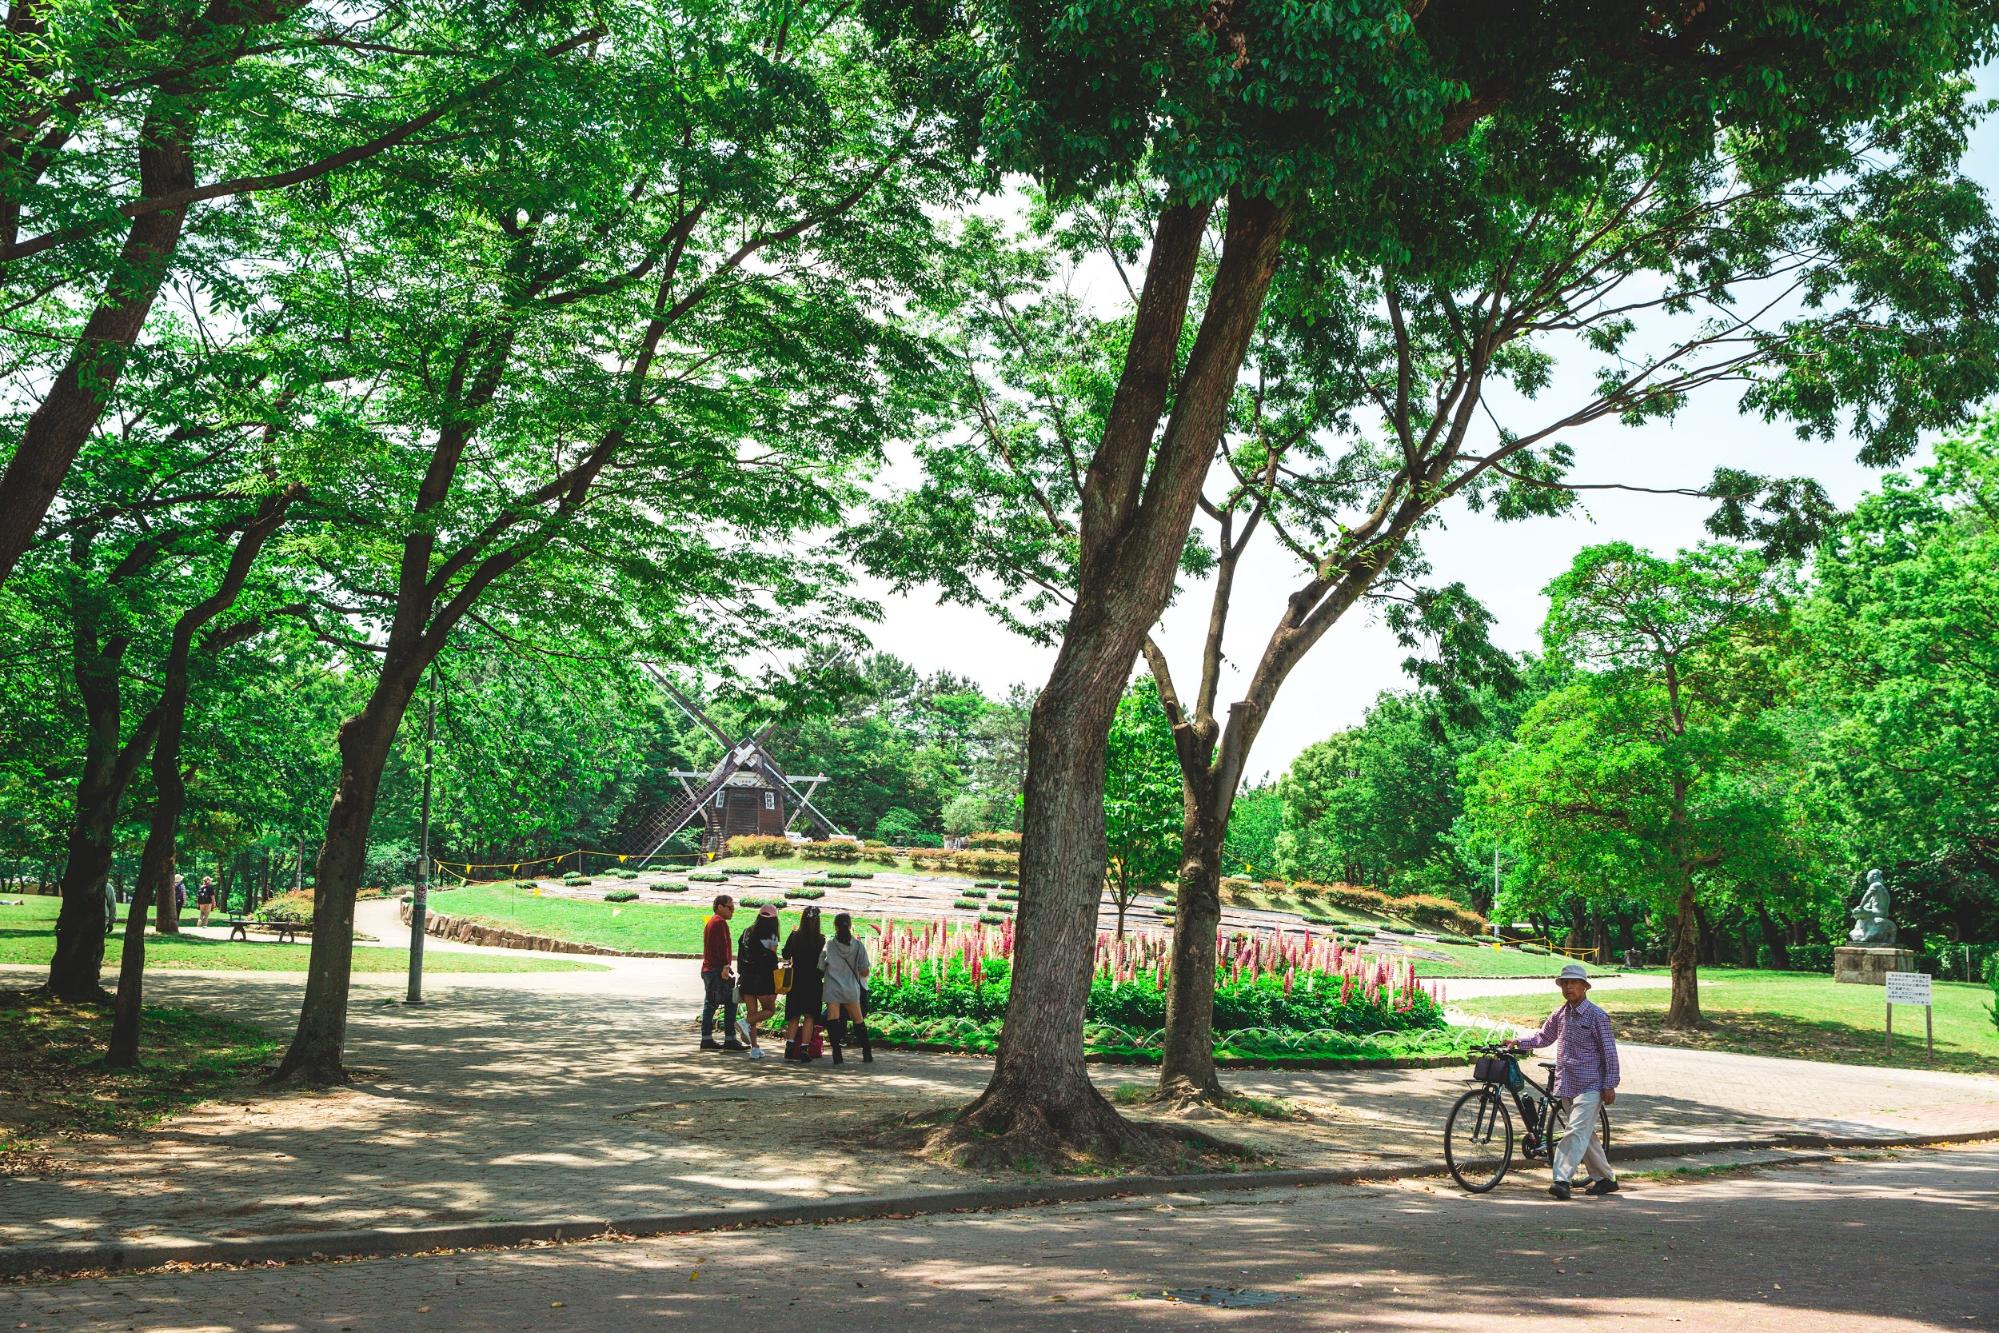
<box><xmin>0</xmin><ymin>0</ymin><xmax>602</xmax><ymax>582</ymax></box>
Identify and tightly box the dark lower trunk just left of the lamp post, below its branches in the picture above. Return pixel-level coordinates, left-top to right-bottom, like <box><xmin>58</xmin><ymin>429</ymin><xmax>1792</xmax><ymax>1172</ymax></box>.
<box><xmin>278</xmin><ymin>683</ymin><xmax>416</xmax><ymax>1085</ymax></box>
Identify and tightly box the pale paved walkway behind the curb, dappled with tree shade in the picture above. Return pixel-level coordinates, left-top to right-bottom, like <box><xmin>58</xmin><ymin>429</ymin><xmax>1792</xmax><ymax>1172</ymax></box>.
<box><xmin>0</xmin><ymin>943</ymin><xmax>1999</xmax><ymax>1245</ymax></box>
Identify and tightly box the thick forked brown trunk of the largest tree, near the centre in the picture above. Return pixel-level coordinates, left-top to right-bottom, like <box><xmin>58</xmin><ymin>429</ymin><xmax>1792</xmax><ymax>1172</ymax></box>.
<box><xmin>946</xmin><ymin>196</ymin><xmax>1289</xmax><ymax>1161</ymax></box>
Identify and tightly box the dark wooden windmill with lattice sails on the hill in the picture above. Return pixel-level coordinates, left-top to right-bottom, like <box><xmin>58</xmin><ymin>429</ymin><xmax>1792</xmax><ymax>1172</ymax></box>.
<box><xmin>628</xmin><ymin>664</ymin><xmax>840</xmax><ymax>855</ymax></box>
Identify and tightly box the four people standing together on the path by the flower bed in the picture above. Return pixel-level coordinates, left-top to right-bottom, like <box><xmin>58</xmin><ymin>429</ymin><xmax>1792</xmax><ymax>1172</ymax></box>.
<box><xmin>702</xmin><ymin>893</ymin><xmax>874</xmax><ymax>1065</ymax></box>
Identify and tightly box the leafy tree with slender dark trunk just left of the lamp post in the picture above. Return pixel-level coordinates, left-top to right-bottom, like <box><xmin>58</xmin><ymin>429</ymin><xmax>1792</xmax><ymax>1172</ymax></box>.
<box><xmin>274</xmin><ymin>4</ymin><xmax>952</xmax><ymax>1081</ymax></box>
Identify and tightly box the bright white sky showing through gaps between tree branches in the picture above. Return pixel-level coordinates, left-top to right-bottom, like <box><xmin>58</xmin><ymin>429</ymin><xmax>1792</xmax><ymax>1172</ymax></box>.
<box><xmin>868</xmin><ymin>70</ymin><xmax>1999</xmax><ymax>779</ymax></box>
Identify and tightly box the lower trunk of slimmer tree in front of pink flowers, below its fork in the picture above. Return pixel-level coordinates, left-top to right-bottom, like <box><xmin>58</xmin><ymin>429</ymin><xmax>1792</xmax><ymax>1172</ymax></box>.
<box><xmin>1159</xmin><ymin>799</ymin><xmax>1227</xmax><ymax>1105</ymax></box>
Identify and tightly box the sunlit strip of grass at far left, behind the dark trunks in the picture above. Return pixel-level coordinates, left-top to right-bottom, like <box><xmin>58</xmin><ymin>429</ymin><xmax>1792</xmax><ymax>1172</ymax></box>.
<box><xmin>0</xmin><ymin>895</ymin><xmax>608</xmax><ymax>973</ymax></box>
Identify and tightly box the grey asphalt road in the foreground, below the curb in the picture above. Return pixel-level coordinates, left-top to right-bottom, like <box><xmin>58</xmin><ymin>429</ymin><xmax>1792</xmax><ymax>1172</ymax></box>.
<box><xmin>0</xmin><ymin>1151</ymin><xmax>1999</xmax><ymax>1333</ymax></box>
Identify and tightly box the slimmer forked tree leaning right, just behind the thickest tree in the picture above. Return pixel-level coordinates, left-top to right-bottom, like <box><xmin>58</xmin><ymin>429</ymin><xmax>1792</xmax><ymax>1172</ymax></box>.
<box><xmin>876</xmin><ymin>84</ymin><xmax>1999</xmax><ymax>1099</ymax></box>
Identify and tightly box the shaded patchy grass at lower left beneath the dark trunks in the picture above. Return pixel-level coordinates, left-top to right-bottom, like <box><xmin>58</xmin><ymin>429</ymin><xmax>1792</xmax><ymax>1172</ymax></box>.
<box><xmin>0</xmin><ymin>991</ymin><xmax>280</xmax><ymax>1177</ymax></box>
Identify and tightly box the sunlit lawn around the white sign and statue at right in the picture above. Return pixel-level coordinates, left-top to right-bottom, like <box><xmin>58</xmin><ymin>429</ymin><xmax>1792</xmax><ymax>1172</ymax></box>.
<box><xmin>1451</xmin><ymin>967</ymin><xmax>1999</xmax><ymax>1075</ymax></box>
